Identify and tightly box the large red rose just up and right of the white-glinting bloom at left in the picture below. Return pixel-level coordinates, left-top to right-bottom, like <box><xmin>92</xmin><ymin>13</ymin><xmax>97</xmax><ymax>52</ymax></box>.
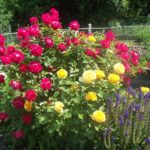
<box><xmin>29</xmin><ymin>44</ymin><xmax>43</xmax><ymax>57</ymax></box>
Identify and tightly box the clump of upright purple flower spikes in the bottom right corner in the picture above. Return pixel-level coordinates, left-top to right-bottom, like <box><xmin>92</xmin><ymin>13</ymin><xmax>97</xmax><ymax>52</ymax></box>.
<box><xmin>103</xmin><ymin>87</ymin><xmax>150</xmax><ymax>150</ymax></box>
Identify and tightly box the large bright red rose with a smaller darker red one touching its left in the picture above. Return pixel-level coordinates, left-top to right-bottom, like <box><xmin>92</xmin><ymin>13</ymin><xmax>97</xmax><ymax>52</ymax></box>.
<box><xmin>28</xmin><ymin>61</ymin><xmax>43</xmax><ymax>74</ymax></box>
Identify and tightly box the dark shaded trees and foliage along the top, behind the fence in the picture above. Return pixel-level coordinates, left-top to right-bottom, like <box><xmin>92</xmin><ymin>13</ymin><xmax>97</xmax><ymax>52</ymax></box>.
<box><xmin>0</xmin><ymin>0</ymin><xmax>150</xmax><ymax>30</ymax></box>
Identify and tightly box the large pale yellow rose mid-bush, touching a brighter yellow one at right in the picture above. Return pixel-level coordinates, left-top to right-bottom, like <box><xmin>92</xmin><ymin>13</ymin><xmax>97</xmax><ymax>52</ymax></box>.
<box><xmin>82</xmin><ymin>70</ymin><xmax>96</xmax><ymax>84</ymax></box>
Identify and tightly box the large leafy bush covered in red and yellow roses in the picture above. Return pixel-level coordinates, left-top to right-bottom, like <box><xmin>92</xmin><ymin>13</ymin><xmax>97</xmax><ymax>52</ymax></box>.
<box><xmin>0</xmin><ymin>8</ymin><xmax>145</xmax><ymax>150</ymax></box>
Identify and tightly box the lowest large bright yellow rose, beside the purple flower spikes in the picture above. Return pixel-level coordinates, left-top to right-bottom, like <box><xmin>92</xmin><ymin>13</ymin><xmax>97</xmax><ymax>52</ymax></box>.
<box><xmin>91</xmin><ymin>110</ymin><xmax>106</xmax><ymax>123</ymax></box>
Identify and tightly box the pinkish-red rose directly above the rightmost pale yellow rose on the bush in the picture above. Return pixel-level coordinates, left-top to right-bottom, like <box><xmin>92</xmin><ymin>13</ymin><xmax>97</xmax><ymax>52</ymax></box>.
<box><xmin>115</xmin><ymin>42</ymin><xmax>128</xmax><ymax>54</ymax></box>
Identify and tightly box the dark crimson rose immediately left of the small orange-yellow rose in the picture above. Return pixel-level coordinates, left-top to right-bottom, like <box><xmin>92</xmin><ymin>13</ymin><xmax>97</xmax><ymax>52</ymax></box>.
<box><xmin>12</xmin><ymin>96</ymin><xmax>24</xmax><ymax>109</ymax></box>
